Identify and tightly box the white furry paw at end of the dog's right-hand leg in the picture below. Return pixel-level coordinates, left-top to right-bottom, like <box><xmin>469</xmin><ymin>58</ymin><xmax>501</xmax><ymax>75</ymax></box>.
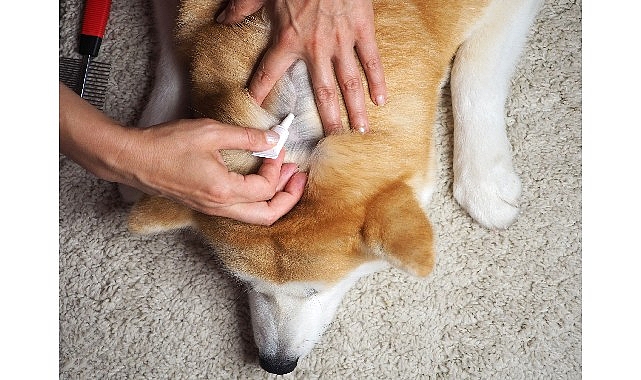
<box><xmin>454</xmin><ymin>162</ymin><xmax>521</xmax><ymax>229</ymax></box>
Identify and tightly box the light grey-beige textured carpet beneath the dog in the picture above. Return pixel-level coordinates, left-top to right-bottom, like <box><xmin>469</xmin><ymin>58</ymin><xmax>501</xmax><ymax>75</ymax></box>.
<box><xmin>59</xmin><ymin>0</ymin><xmax>582</xmax><ymax>379</ymax></box>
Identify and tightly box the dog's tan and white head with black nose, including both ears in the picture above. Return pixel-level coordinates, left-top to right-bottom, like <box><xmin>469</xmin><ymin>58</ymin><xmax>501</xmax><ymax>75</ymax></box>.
<box><xmin>130</xmin><ymin>171</ymin><xmax>434</xmax><ymax>373</ymax></box>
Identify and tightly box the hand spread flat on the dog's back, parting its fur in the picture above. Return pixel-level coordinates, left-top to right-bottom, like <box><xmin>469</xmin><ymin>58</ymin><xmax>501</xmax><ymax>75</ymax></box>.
<box><xmin>217</xmin><ymin>0</ymin><xmax>387</xmax><ymax>133</ymax></box>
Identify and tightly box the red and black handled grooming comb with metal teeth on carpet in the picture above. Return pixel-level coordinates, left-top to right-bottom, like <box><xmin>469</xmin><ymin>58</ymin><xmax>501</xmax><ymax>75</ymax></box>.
<box><xmin>59</xmin><ymin>0</ymin><xmax>111</xmax><ymax>109</ymax></box>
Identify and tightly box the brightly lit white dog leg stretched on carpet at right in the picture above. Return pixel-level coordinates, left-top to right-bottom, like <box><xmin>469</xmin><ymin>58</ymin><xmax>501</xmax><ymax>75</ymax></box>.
<box><xmin>451</xmin><ymin>0</ymin><xmax>542</xmax><ymax>228</ymax></box>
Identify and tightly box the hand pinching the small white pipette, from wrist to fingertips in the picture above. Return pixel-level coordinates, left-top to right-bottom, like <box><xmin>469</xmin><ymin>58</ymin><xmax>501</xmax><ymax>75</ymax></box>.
<box><xmin>122</xmin><ymin>119</ymin><xmax>307</xmax><ymax>225</ymax></box>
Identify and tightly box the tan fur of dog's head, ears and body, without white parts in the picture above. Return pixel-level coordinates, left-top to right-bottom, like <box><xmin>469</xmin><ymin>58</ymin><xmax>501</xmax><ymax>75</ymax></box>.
<box><xmin>130</xmin><ymin>0</ymin><xmax>487</xmax><ymax>283</ymax></box>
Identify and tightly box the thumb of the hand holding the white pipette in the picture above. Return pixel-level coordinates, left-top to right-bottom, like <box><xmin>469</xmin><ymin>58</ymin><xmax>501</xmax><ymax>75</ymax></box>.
<box><xmin>216</xmin><ymin>125</ymin><xmax>280</xmax><ymax>152</ymax></box>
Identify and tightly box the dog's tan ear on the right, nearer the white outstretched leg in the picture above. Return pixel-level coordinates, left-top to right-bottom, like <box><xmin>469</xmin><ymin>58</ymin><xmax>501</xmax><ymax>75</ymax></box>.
<box><xmin>362</xmin><ymin>183</ymin><xmax>434</xmax><ymax>276</ymax></box>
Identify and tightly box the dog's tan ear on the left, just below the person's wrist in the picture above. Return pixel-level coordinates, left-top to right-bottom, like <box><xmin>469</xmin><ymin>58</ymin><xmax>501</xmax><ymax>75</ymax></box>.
<box><xmin>128</xmin><ymin>195</ymin><xmax>194</xmax><ymax>234</ymax></box>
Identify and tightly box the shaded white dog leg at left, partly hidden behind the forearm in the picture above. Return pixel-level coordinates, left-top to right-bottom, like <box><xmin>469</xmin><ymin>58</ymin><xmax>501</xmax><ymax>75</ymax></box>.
<box><xmin>118</xmin><ymin>0</ymin><xmax>189</xmax><ymax>203</ymax></box>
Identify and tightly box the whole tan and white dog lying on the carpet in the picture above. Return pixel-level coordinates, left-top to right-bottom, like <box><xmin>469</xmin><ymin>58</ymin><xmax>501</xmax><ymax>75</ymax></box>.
<box><xmin>123</xmin><ymin>0</ymin><xmax>542</xmax><ymax>374</ymax></box>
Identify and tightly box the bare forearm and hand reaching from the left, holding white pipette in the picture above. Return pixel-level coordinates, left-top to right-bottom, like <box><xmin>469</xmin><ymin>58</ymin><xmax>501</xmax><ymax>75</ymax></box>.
<box><xmin>60</xmin><ymin>84</ymin><xmax>307</xmax><ymax>224</ymax></box>
